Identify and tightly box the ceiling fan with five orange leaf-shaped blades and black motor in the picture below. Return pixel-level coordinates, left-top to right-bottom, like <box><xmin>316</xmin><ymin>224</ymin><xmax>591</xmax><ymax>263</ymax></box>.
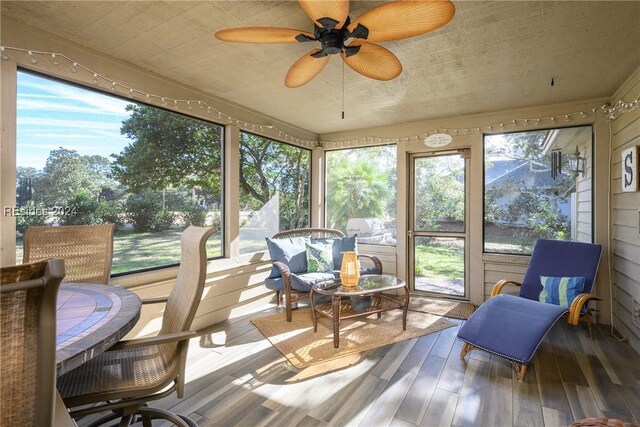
<box><xmin>215</xmin><ymin>0</ymin><xmax>455</xmax><ymax>87</ymax></box>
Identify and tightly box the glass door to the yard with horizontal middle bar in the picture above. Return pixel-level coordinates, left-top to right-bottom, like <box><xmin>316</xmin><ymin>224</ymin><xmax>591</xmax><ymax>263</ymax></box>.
<box><xmin>407</xmin><ymin>150</ymin><xmax>469</xmax><ymax>300</ymax></box>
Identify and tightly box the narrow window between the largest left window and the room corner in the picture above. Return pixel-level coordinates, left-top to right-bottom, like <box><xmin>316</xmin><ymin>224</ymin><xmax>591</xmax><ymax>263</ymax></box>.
<box><xmin>240</xmin><ymin>132</ymin><xmax>311</xmax><ymax>253</ymax></box>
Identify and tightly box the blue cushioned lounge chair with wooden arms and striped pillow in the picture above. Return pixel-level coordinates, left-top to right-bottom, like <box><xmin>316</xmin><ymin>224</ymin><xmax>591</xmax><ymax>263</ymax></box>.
<box><xmin>458</xmin><ymin>240</ymin><xmax>602</xmax><ymax>381</ymax></box>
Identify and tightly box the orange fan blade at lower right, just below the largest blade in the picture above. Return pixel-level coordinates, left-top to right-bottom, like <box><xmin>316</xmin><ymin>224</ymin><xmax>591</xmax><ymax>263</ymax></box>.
<box><xmin>340</xmin><ymin>41</ymin><xmax>402</xmax><ymax>80</ymax></box>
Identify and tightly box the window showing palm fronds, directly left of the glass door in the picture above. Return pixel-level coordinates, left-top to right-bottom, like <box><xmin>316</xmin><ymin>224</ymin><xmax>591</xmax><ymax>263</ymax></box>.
<box><xmin>325</xmin><ymin>145</ymin><xmax>396</xmax><ymax>245</ymax></box>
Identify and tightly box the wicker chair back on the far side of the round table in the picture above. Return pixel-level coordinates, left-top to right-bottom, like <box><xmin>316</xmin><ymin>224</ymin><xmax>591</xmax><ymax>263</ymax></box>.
<box><xmin>23</xmin><ymin>224</ymin><xmax>114</xmax><ymax>285</ymax></box>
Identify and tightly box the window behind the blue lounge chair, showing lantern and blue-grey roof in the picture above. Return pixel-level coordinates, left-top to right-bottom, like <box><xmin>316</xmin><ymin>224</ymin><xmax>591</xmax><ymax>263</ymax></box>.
<box><xmin>484</xmin><ymin>126</ymin><xmax>593</xmax><ymax>254</ymax></box>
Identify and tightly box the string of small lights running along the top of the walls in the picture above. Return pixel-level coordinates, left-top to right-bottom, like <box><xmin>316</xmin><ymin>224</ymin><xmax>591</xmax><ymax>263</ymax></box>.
<box><xmin>0</xmin><ymin>46</ymin><xmax>640</xmax><ymax>148</ymax></box>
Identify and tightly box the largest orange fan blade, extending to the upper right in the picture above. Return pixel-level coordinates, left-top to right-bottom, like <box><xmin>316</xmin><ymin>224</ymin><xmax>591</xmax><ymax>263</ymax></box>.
<box><xmin>349</xmin><ymin>1</ymin><xmax>456</xmax><ymax>42</ymax></box>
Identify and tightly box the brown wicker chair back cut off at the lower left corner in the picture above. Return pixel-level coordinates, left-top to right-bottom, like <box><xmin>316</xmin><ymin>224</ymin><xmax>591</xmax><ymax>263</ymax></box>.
<box><xmin>0</xmin><ymin>259</ymin><xmax>64</xmax><ymax>426</ymax></box>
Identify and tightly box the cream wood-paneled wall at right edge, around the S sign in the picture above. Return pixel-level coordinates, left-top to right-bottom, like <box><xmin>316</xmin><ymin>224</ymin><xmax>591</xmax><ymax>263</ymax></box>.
<box><xmin>611</xmin><ymin>69</ymin><xmax>640</xmax><ymax>352</ymax></box>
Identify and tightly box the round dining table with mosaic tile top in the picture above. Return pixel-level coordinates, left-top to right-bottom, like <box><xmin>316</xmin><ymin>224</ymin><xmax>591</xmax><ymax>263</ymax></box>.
<box><xmin>56</xmin><ymin>283</ymin><xmax>142</xmax><ymax>376</ymax></box>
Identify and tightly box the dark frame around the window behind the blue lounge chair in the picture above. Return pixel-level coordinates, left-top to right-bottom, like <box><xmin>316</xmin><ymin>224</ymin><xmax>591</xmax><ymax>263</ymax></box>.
<box><xmin>482</xmin><ymin>123</ymin><xmax>597</xmax><ymax>256</ymax></box>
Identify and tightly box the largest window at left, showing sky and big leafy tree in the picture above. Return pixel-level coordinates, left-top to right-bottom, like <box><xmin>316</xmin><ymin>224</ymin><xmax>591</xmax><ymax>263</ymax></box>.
<box><xmin>16</xmin><ymin>72</ymin><xmax>223</xmax><ymax>274</ymax></box>
